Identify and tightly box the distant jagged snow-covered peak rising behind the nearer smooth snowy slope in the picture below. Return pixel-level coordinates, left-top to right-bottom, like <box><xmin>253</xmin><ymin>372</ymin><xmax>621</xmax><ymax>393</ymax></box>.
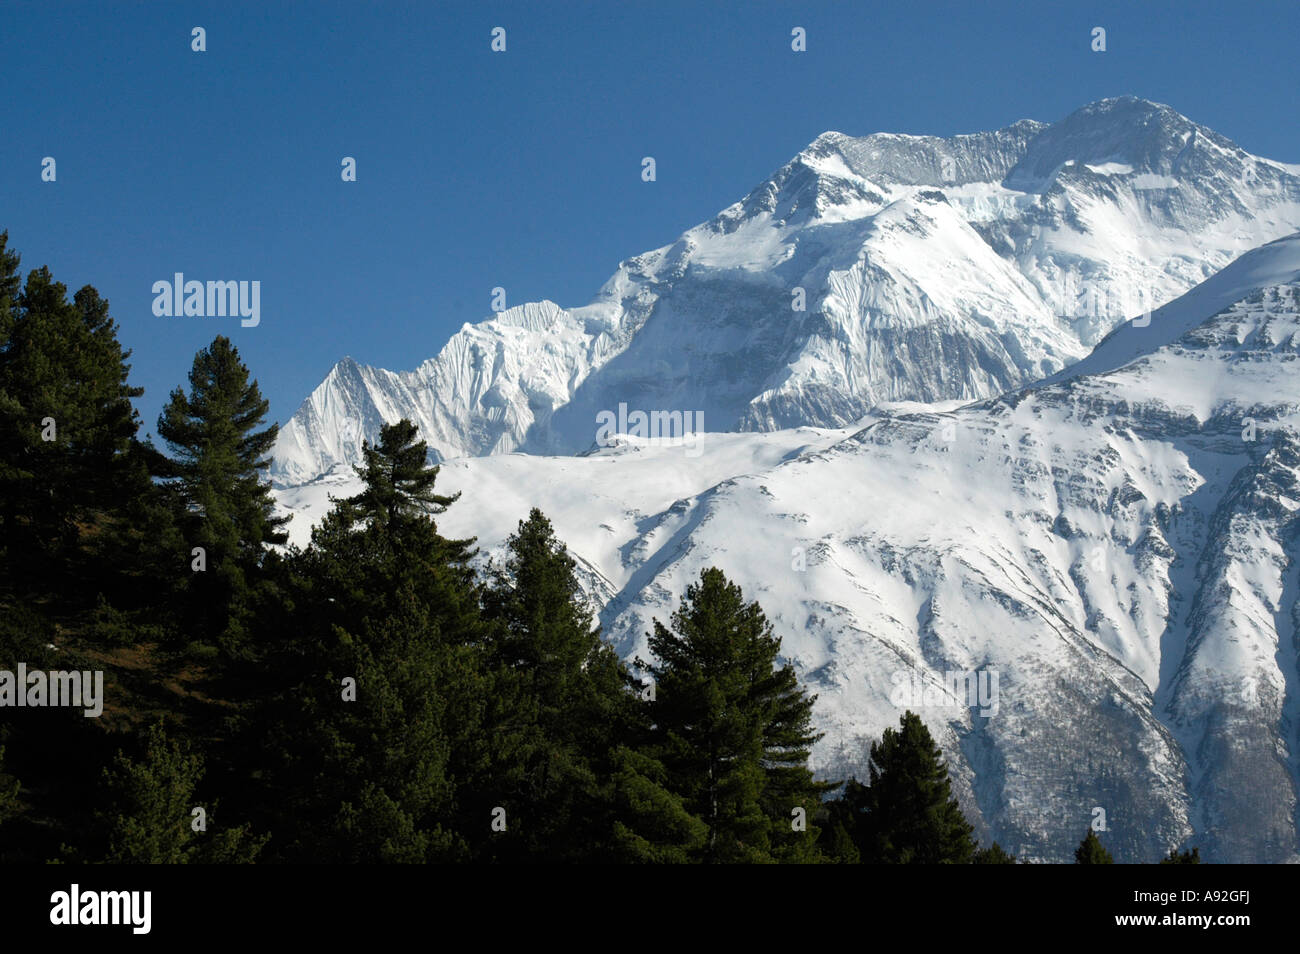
<box><xmin>273</xmin><ymin>97</ymin><xmax>1300</xmax><ymax>485</ymax></box>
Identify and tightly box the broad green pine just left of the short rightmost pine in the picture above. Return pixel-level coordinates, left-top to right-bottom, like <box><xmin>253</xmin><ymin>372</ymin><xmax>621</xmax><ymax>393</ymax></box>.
<box><xmin>638</xmin><ymin>568</ymin><xmax>831</xmax><ymax>862</ymax></box>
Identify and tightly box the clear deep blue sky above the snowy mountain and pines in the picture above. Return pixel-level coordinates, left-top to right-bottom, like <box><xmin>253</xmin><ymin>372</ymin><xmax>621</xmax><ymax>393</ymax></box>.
<box><xmin>0</xmin><ymin>0</ymin><xmax>1300</xmax><ymax>432</ymax></box>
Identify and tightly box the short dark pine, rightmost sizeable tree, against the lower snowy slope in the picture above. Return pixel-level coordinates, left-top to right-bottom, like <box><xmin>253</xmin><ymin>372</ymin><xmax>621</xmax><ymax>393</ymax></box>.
<box><xmin>837</xmin><ymin>711</ymin><xmax>975</xmax><ymax>864</ymax></box>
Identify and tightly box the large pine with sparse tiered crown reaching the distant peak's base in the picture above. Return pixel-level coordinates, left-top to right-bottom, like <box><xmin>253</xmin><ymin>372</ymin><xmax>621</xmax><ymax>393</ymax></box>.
<box><xmin>252</xmin><ymin>422</ymin><xmax>488</xmax><ymax>862</ymax></box>
